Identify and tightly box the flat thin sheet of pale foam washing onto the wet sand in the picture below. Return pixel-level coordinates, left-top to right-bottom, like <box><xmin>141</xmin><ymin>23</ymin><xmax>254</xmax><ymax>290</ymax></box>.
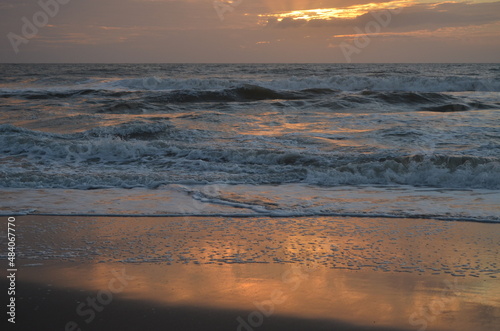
<box><xmin>0</xmin><ymin>184</ymin><xmax>500</xmax><ymax>223</ymax></box>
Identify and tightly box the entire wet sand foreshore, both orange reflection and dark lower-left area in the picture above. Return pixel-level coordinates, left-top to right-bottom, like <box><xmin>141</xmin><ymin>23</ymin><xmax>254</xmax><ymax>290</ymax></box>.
<box><xmin>2</xmin><ymin>216</ymin><xmax>500</xmax><ymax>330</ymax></box>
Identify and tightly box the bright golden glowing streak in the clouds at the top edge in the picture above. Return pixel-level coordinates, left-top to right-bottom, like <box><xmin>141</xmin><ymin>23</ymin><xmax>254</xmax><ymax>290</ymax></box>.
<box><xmin>259</xmin><ymin>0</ymin><xmax>415</xmax><ymax>21</ymax></box>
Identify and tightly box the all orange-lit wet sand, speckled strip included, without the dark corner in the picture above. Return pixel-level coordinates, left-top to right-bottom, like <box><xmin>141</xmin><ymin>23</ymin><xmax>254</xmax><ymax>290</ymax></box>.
<box><xmin>15</xmin><ymin>218</ymin><xmax>500</xmax><ymax>330</ymax></box>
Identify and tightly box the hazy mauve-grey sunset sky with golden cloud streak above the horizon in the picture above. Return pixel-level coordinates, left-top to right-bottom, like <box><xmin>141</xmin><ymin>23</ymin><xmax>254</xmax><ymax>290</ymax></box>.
<box><xmin>0</xmin><ymin>0</ymin><xmax>500</xmax><ymax>63</ymax></box>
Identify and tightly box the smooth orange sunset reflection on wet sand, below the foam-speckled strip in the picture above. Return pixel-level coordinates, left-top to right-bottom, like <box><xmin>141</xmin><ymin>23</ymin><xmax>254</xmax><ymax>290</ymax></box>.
<box><xmin>16</xmin><ymin>264</ymin><xmax>500</xmax><ymax>330</ymax></box>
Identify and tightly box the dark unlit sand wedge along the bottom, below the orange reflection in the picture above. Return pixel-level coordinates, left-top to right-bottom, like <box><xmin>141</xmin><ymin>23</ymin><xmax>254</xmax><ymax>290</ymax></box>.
<box><xmin>6</xmin><ymin>282</ymin><xmax>414</xmax><ymax>331</ymax></box>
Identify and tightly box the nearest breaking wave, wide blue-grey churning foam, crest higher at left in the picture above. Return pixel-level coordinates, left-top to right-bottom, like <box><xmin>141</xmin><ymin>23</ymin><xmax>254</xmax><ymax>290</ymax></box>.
<box><xmin>0</xmin><ymin>122</ymin><xmax>500</xmax><ymax>189</ymax></box>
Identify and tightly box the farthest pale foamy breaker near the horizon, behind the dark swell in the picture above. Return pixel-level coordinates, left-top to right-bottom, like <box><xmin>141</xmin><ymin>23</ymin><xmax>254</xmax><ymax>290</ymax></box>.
<box><xmin>0</xmin><ymin>74</ymin><xmax>500</xmax><ymax>99</ymax></box>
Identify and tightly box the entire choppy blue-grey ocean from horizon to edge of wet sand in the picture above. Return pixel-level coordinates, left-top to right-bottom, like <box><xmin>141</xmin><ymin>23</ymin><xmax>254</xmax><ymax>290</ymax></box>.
<box><xmin>0</xmin><ymin>64</ymin><xmax>500</xmax><ymax>222</ymax></box>
